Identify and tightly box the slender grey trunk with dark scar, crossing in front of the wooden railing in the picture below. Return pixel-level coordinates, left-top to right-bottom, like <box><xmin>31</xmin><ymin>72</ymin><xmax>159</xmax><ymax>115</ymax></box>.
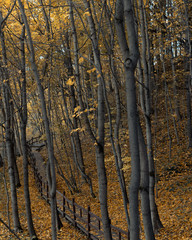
<box><xmin>83</xmin><ymin>0</ymin><xmax>112</xmax><ymax>240</ymax></box>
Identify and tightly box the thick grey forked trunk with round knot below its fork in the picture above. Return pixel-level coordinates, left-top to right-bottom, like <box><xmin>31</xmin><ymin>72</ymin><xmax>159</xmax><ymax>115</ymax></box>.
<box><xmin>115</xmin><ymin>0</ymin><xmax>140</xmax><ymax>240</ymax></box>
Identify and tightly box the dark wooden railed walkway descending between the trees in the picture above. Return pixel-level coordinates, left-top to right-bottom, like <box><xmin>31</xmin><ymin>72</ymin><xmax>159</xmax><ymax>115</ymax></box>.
<box><xmin>30</xmin><ymin>153</ymin><xmax>130</xmax><ymax>240</ymax></box>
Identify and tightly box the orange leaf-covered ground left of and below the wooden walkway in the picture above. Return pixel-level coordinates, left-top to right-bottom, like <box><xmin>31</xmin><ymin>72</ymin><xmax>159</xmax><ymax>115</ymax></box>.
<box><xmin>0</xmin><ymin>159</ymin><xmax>86</xmax><ymax>240</ymax></box>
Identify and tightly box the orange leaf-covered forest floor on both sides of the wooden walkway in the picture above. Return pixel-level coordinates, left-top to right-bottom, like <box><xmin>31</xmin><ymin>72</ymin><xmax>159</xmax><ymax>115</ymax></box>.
<box><xmin>0</xmin><ymin>121</ymin><xmax>192</xmax><ymax>240</ymax></box>
